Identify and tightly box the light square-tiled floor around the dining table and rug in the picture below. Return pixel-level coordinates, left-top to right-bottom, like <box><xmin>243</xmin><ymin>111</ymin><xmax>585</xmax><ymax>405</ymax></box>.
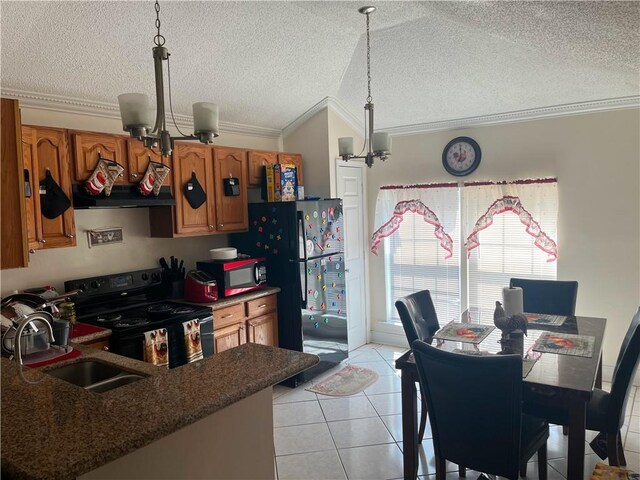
<box><xmin>273</xmin><ymin>344</ymin><xmax>640</xmax><ymax>480</ymax></box>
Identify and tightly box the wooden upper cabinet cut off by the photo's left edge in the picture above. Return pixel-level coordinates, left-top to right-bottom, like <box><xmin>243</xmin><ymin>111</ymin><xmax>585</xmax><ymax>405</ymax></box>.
<box><xmin>0</xmin><ymin>98</ymin><xmax>29</xmax><ymax>269</ymax></box>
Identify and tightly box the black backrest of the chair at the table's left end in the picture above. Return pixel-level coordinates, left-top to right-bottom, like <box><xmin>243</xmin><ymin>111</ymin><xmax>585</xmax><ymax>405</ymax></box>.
<box><xmin>396</xmin><ymin>290</ymin><xmax>440</xmax><ymax>346</ymax></box>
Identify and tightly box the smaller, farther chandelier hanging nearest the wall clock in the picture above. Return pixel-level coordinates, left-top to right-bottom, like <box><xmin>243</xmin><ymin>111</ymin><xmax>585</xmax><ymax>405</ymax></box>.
<box><xmin>338</xmin><ymin>6</ymin><xmax>391</xmax><ymax>168</ymax></box>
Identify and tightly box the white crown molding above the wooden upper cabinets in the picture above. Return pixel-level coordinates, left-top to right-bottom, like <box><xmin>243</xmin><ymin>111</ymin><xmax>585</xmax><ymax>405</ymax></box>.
<box><xmin>1</xmin><ymin>88</ymin><xmax>282</xmax><ymax>138</ymax></box>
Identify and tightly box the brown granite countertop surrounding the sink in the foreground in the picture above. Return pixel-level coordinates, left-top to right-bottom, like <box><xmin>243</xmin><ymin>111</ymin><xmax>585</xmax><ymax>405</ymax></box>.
<box><xmin>0</xmin><ymin>343</ymin><xmax>318</xmax><ymax>479</ymax></box>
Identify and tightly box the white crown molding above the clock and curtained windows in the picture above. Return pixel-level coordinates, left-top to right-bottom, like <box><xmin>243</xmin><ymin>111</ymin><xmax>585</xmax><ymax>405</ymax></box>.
<box><xmin>383</xmin><ymin>95</ymin><xmax>640</xmax><ymax>136</ymax></box>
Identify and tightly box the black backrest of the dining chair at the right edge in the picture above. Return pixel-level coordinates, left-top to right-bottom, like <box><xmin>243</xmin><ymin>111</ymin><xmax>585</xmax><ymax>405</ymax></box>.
<box><xmin>606</xmin><ymin>308</ymin><xmax>640</xmax><ymax>432</ymax></box>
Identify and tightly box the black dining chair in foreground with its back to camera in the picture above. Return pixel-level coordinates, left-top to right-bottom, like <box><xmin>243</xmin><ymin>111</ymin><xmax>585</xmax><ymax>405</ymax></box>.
<box><xmin>412</xmin><ymin>340</ymin><xmax>549</xmax><ymax>480</ymax></box>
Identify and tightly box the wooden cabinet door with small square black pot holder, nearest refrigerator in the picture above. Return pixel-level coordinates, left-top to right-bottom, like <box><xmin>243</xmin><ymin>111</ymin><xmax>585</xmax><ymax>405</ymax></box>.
<box><xmin>213</xmin><ymin>147</ymin><xmax>249</xmax><ymax>232</ymax></box>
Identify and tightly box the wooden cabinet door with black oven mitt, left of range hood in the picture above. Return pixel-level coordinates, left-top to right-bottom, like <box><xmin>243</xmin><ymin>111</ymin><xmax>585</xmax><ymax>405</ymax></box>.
<box><xmin>22</xmin><ymin>125</ymin><xmax>76</xmax><ymax>250</ymax></box>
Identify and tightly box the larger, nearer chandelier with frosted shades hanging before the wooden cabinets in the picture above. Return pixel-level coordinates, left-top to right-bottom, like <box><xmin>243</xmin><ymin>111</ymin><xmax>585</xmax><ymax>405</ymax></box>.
<box><xmin>118</xmin><ymin>0</ymin><xmax>218</xmax><ymax>157</ymax></box>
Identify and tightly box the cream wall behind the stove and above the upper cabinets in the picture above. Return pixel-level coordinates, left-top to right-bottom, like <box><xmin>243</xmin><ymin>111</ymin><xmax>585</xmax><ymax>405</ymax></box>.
<box><xmin>0</xmin><ymin>107</ymin><xmax>281</xmax><ymax>296</ymax></box>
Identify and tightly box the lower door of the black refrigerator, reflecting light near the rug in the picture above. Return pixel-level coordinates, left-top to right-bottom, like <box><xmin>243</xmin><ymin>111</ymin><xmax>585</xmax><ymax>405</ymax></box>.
<box><xmin>300</xmin><ymin>252</ymin><xmax>349</xmax><ymax>374</ymax></box>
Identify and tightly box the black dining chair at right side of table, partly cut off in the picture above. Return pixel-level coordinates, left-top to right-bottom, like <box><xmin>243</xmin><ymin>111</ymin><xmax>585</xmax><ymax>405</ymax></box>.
<box><xmin>524</xmin><ymin>308</ymin><xmax>640</xmax><ymax>466</ymax></box>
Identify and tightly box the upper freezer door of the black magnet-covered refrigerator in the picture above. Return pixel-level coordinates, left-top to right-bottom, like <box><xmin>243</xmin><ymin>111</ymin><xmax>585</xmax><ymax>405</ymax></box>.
<box><xmin>296</xmin><ymin>198</ymin><xmax>344</xmax><ymax>260</ymax></box>
